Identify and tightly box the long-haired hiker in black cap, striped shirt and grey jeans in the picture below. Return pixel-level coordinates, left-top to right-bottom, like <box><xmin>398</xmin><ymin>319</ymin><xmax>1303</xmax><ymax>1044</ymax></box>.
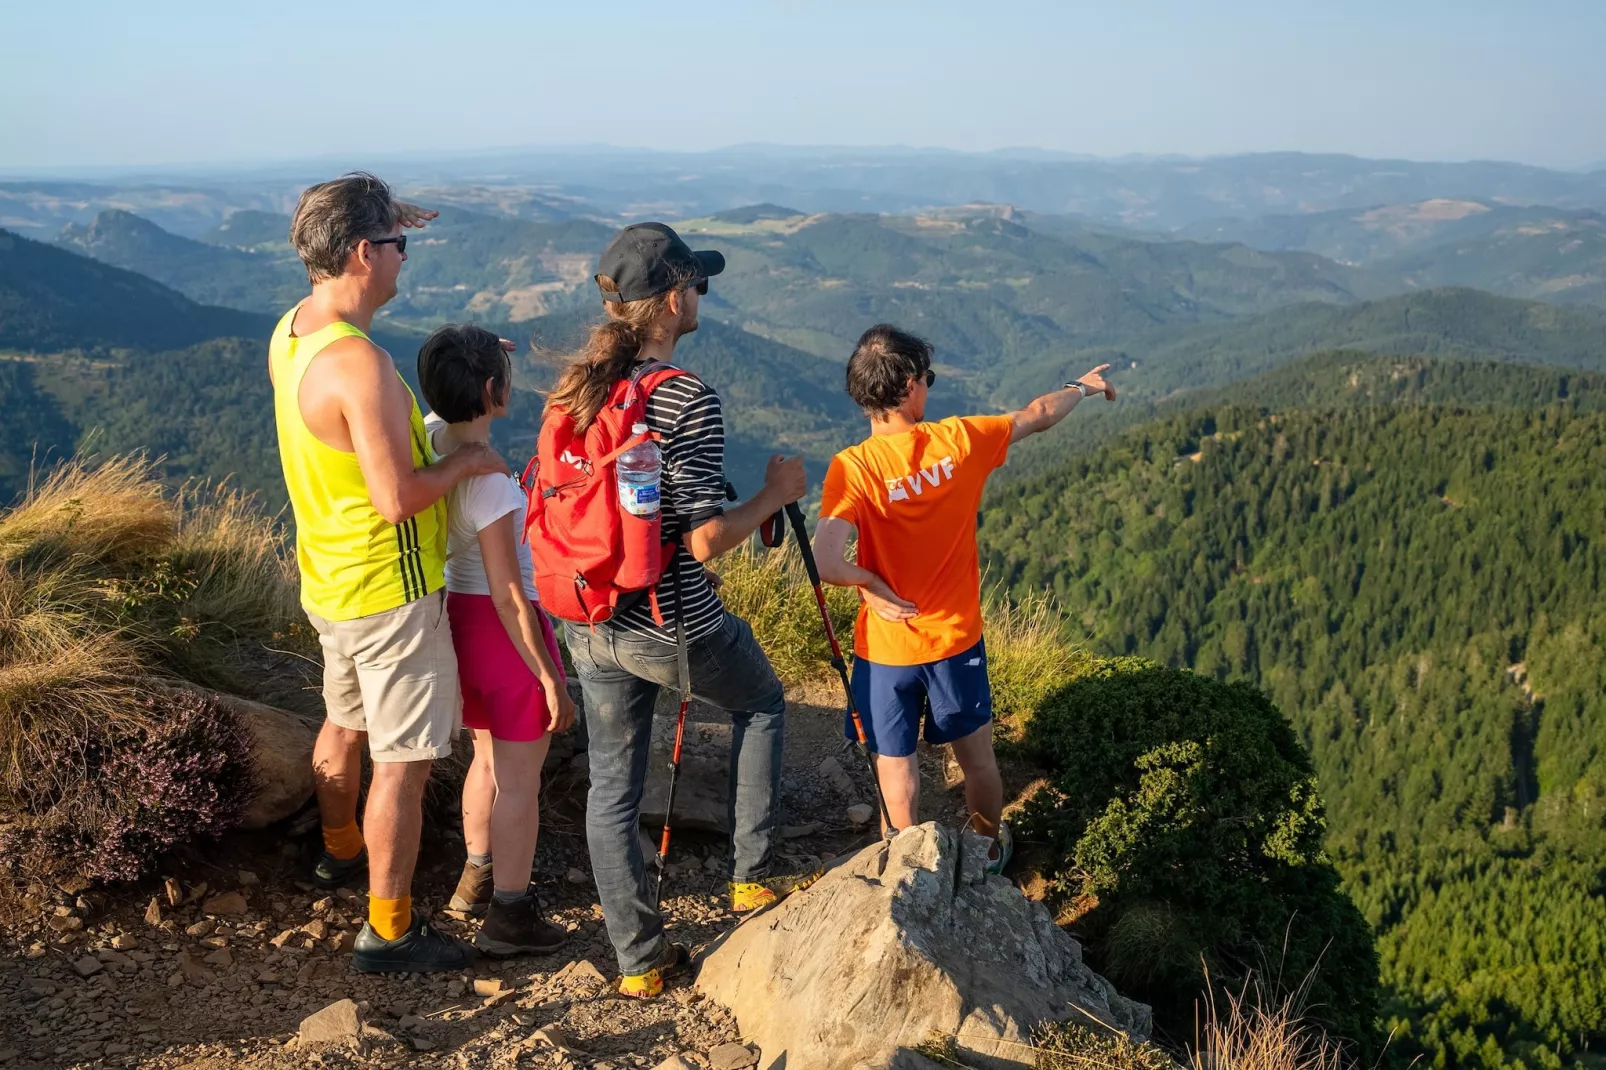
<box><xmin>546</xmin><ymin>223</ymin><xmax>808</xmax><ymax>998</ymax></box>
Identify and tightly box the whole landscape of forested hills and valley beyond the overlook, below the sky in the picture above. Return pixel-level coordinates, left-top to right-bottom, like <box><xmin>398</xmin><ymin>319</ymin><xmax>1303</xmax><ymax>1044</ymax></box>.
<box><xmin>0</xmin><ymin>149</ymin><xmax>1606</xmax><ymax>1070</ymax></box>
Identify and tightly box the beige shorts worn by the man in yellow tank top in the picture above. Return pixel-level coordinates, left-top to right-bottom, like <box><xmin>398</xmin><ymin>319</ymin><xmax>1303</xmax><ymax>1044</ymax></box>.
<box><xmin>307</xmin><ymin>590</ymin><xmax>463</xmax><ymax>762</ymax></box>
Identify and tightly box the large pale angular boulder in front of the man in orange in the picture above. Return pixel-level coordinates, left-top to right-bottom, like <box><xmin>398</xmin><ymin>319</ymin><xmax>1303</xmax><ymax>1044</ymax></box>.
<box><xmin>697</xmin><ymin>823</ymin><xmax>1150</xmax><ymax>1070</ymax></box>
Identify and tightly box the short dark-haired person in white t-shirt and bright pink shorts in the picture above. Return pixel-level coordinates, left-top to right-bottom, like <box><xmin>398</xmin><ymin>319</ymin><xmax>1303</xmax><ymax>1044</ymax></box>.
<box><xmin>418</xmin><ymin>325</ymin><xmax>575</xmax><ymax>954</ymax></box>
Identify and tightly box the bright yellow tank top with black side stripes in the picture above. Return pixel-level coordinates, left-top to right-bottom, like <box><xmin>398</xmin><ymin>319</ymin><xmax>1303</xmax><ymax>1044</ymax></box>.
<box><xmin>268</xmin><ymin>305</ymin><xmax>446</xmax><ymax>620</ymax></box>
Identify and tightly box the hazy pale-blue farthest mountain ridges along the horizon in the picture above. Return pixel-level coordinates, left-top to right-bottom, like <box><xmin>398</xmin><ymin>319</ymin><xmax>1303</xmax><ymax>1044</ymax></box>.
<box><xmin>9</xmin><ymin>146</ymin><xmax>1606</xmax><ymax>238</ymax></box>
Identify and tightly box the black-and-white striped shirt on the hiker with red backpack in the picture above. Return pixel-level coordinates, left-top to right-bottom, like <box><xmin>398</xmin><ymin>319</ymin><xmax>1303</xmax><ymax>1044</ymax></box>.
<box><xmin>610</xmin><ymin>363</ymin><xmax>724</xmax><ymax>643</ymax></box>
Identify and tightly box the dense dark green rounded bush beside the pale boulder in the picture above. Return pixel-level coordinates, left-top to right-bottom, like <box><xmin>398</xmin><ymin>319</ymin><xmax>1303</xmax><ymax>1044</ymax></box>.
<box><xmin>1018</xmin><ymin>657</ymin><xmax>1380</xmax><ymax>1059</ymax></box>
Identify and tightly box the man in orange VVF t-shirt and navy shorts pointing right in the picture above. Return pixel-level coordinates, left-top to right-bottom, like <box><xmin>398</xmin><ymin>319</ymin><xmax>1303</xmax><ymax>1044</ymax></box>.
<box><xmin>814</xmin><ymin>325</ymin><xmax>1115</xmax><ymax>872</ymax></box>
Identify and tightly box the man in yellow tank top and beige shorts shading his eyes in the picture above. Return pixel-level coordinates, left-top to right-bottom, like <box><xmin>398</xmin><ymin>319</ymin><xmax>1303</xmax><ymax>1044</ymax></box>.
<box><xmin>268</xmin><ymin>174</ymin><xmax>507</xmax><ymax>972</ymax></box>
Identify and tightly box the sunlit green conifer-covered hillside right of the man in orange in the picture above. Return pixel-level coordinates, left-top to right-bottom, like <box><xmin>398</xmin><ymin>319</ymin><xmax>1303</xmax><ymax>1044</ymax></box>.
<box><xmin>981</xmin><ymin>387</ymin><xmax>1606</xmax><ymax>1067</ymax></box>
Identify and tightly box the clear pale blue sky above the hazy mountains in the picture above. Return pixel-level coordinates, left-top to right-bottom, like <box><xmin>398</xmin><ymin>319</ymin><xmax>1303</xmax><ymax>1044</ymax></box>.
<box><xmin>0</xmin><ymin>0</ymin><xmax>1606</xmax><ymax>170</ymax></box>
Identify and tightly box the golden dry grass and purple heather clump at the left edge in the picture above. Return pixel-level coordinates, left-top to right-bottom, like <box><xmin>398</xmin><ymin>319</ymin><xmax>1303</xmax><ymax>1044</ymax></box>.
<box><xmin>0</xmin><ymin>456</ymin><xmax>297</xmax><ymax>879</ymax></box>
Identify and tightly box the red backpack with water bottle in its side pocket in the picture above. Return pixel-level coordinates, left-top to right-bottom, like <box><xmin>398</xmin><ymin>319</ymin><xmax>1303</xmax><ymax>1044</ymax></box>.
<box><xmin>524</xmin><ymin>363</ymin><xmax>691</xmax><ymax>625</ymax></box>
